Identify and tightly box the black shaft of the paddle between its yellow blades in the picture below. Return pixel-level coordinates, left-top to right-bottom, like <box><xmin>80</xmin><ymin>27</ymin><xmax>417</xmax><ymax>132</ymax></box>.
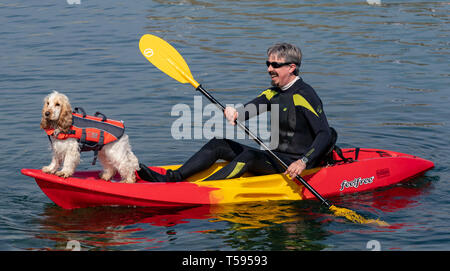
<box><xmin>196</xmin><ymin>85</ymin><xmax>331</xmax><ymax>208</ymax></box>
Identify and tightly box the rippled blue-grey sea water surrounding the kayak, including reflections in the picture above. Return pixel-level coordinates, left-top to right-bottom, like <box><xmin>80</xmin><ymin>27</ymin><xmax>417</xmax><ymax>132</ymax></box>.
<box><xmin>0</xmin><ymin>0</ymin><xmax>450</xmax><ymax>250</ymax></box>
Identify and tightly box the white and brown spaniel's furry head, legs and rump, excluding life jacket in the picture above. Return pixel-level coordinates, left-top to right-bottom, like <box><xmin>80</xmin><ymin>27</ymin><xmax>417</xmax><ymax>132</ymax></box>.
<box><xmin>41</xmin><ymin>91</ymin><xmax>139</xmax><ymax>183</ymax></box>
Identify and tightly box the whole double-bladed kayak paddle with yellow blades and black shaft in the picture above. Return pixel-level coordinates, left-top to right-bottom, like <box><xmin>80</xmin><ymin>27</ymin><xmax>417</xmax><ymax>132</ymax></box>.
<box><xmin>139</xmin><ymin>34</ymin><xmax>389</xmax><ymax>226</ymax></box>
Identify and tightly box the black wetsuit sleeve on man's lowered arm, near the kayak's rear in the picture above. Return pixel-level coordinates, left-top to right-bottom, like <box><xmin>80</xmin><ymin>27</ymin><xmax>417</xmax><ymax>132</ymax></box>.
<box><xmin>294</xmin><ymin>94</ymin><xmax>331</xmax><ymax>164</ymax></box>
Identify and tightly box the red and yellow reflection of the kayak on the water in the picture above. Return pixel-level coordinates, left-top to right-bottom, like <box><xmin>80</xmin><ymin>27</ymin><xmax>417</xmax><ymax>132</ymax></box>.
<box><xmin>30</xmin><ymin>178</ymin><xmax>431</xmax><ymax>250</ymax></box>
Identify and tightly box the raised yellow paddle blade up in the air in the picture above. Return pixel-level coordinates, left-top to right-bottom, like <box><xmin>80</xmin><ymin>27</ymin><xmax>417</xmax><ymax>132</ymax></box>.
<box><xmin>139</xmin><ymin>34</ymin><xmax>200</xmax><ymax>88</ymax></box>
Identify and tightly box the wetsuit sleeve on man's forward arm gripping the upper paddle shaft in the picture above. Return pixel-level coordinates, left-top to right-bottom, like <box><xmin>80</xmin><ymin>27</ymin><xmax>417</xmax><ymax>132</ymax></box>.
<box><xmin>236</xmin><ymin>89</ymin><xmax>276</xmax><ymax>122</ymax></box>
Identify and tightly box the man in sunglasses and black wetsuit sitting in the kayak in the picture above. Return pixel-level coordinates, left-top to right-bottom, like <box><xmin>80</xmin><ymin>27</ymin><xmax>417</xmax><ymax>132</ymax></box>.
<box><xmin>138</xmin><ymin>43</ymin><xmax>332</xmax><ymax>182</ymax></box>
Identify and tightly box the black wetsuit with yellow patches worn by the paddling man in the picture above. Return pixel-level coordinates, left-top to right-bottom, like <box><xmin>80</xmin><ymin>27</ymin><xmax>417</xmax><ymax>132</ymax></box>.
<box><xmin>138</xmin><ymin>78</ymin><xmax>331</xmax><ymax>181</ymax></box>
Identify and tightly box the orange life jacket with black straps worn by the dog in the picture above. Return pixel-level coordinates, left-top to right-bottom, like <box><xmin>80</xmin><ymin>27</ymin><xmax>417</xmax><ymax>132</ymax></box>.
<box><xmin>45</xmin><ymin>107</ymin><xmax>125</xmax><ymax>165</ymax></box>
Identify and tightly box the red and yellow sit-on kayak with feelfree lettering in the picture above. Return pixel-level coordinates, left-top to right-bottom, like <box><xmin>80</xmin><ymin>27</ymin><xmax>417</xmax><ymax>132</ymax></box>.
<box><xmin>21</xmin><ymin>148</ymin><xmax>434</xmax><ymax>209</ymax></box>
